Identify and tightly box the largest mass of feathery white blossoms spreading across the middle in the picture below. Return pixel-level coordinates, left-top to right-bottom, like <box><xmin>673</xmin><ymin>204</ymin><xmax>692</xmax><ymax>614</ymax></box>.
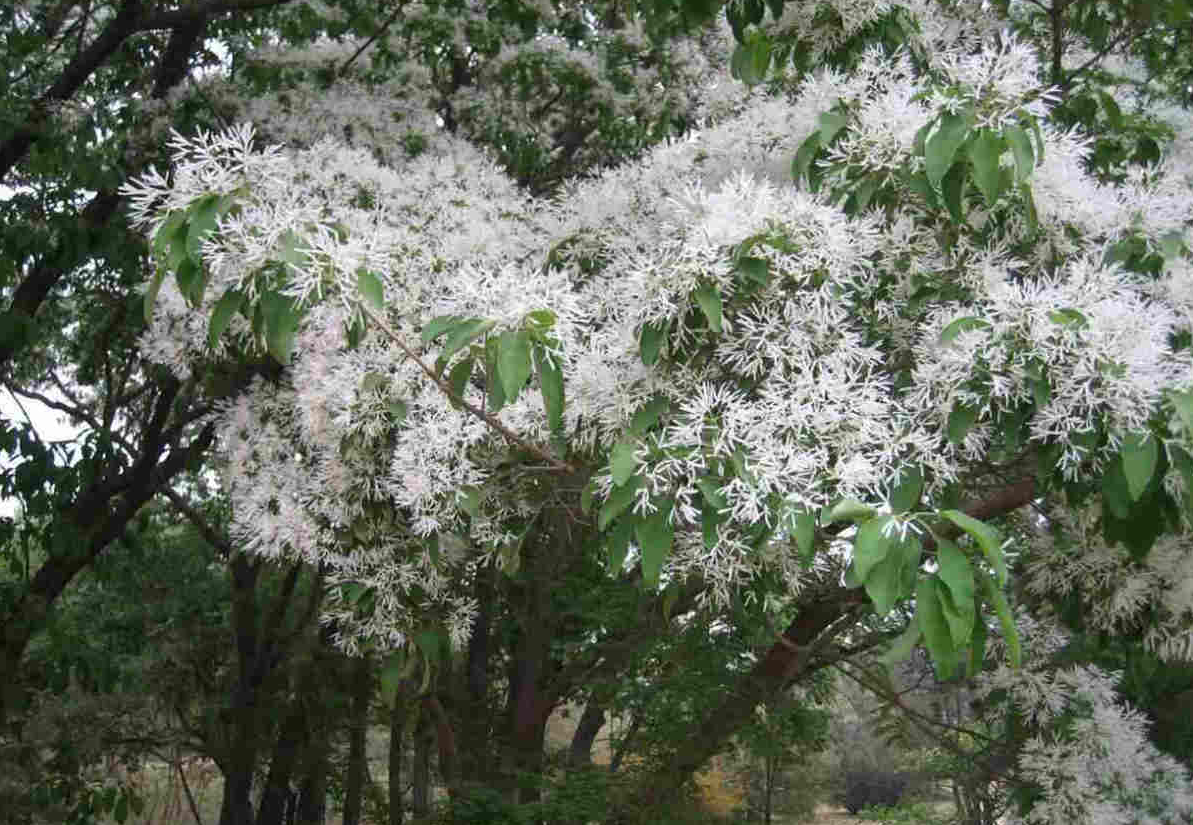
<box><xmin>128</xmin><ymin>4</ymin><xmax>1191</xmax><ymax>658</ymax></box>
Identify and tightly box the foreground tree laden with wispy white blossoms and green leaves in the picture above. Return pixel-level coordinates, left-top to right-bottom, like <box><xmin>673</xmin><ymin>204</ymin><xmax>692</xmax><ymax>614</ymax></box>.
<box><xmin>124</xmin><ymin>0</ymin><xmax>1193</xmax><ymax>821</ymax></box>
